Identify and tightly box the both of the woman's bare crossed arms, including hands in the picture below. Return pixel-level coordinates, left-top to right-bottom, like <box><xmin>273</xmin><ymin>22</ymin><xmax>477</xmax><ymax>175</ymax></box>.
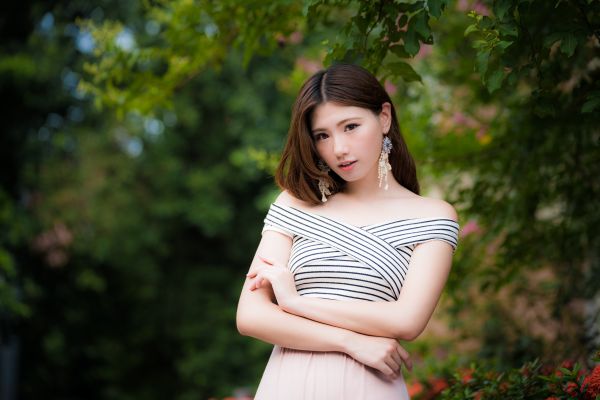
<box><xmin>237</xmin><ymin>209</ymin><xmax>452</xmax><ymax>378</ymax></box>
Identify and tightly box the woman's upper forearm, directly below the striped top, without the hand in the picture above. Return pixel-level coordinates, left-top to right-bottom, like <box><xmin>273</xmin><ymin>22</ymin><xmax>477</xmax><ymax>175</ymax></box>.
<box><xmin>282</xmin><ymin>296</ymin><xmax>422</xmax><ymax>340</ymax></box>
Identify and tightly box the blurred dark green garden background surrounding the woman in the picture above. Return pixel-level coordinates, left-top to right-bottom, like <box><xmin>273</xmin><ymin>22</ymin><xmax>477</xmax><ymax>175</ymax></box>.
<box><xmin>0</xmin><ymin>0</ymin><xmax>600</xmax><ymax>400</ymax></box>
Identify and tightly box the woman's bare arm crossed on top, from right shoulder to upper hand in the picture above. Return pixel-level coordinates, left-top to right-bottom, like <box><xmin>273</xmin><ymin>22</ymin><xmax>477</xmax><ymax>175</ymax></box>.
<box><xmin>249</xmin><ymin>240</ymin><xmax>453</xmax><ymax>340</ymax></box>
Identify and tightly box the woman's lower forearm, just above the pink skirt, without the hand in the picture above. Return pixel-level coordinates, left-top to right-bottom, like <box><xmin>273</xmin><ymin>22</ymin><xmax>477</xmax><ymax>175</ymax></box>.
<box><xmin>237</xmin><ymin>296</ymin><xmax>355</xmax><ymax>353</ymax></box>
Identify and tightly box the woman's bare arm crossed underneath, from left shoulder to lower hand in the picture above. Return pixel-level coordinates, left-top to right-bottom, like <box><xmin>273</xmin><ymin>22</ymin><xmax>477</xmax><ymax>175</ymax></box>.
<box><xmin>236</xmin><ymin>230</ymin><xmax>411</xmax><ymax>377</ymax></box>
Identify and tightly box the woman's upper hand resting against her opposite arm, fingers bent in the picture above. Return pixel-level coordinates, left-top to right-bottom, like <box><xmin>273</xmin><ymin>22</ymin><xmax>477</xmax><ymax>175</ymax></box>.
<box><xmin>246</xmin><ymin>255</ymin><xmax>299</xmax><ymax>308</ymax></box>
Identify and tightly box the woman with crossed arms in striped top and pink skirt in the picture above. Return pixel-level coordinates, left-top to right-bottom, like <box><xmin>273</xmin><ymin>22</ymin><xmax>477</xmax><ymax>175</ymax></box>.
<box><xmin>237</xmin><ymin>64</ymin><xmax>459</xmax><ymax>400</ymax></box>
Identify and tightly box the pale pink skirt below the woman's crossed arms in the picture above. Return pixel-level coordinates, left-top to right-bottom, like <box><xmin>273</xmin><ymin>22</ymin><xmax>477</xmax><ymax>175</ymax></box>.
<box><xmin>254</xmin><ymin>346</ymin><xmax>410</xmax><ymax>400</ymax></box>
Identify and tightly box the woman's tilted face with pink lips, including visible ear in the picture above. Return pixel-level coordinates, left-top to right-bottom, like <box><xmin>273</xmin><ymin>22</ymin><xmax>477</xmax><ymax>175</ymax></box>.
<box><xmin>311</xmin><ymin>102</ymin><xmax>391</xmax><ymax>182</ymax></box>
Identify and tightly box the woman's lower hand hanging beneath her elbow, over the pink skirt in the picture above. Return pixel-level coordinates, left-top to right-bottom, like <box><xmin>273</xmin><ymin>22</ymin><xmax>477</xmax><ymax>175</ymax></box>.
<box><xmin>346</xmin><ymin>333</ymin><xmax>412</xmax><ymax>380</ymax></box>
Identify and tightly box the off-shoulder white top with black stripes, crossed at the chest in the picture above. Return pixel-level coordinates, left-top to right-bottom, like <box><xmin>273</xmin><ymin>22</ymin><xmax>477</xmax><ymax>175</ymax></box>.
<box><xmin>263</xmin><ymin>203</ymin><xmax>459</xmax><ymax>301</ymax></box>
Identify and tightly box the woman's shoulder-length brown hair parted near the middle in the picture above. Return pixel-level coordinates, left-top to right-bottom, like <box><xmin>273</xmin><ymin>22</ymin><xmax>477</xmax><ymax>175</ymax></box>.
<box><xmin>275</xmin><ymin>64</ymin><xmax>419</xmax><ymax>204</ymax></box>
